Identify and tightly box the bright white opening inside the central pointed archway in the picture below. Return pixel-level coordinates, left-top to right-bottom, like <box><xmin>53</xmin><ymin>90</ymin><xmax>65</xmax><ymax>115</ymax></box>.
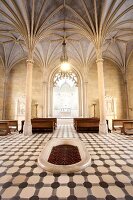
<box><xmin>53</xmin><ymin>72</ymin><xmax>79</xmax><ymax>118</ymax></box>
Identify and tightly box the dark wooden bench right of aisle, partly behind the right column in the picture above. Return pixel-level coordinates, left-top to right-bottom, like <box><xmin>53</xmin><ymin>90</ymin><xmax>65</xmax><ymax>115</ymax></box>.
<box><xmin>74</xmin><ymin>118</ymin><xmax>111</xmax><ymax>133</ymax></box>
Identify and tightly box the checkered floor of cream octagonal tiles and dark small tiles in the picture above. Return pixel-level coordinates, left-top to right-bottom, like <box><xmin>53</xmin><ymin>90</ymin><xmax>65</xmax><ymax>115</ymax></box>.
<box><xmin>0</xmin><ymin>119</ymin><xmax>133</xmax><ymax>200</ymax></box>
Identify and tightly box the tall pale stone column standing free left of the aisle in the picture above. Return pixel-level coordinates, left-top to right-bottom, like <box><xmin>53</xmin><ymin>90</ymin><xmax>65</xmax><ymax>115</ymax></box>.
<box><xmin>23</xmin><ymin>60</ymin><xmax>33</xmax><ymax>136</ymax></box>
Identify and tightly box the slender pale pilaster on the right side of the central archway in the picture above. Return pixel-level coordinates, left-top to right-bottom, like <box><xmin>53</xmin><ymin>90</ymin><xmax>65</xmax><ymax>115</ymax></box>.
<box><xmin>83</xmin><ymin>82</ymin><xmax>89</xmax><ymax>117</ymax></box>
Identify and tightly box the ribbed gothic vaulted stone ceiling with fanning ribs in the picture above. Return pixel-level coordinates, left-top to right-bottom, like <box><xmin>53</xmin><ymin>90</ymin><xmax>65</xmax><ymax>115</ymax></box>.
<box><xmin>0</xmin><ymin>0</ymin><xmax>133</xmax><ymax>72</ymax></box>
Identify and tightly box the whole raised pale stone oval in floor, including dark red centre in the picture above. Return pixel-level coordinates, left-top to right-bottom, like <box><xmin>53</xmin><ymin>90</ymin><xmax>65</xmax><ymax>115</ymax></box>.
<box><xmin>38</xmin><ymin>138</ymin><xmax>91</xmax><ymax>173</ymax></box>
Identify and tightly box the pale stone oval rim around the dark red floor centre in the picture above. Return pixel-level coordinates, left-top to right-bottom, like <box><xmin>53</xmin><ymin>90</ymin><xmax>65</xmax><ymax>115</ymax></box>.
<box><xmin>38</xmin><ymin>138</ymin><xmax>91</xmax><ymax>173</ymax></box>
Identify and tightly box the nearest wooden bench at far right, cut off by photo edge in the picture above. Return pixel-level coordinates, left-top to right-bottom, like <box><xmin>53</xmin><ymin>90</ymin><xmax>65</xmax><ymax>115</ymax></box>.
<box><xmin>122</xmin><ymin>121</ymin><xmax>133</xmax><ymax>135</ymax></box>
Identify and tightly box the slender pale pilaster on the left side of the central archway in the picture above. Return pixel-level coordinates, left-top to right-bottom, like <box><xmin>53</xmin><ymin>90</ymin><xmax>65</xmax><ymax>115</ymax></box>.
<box><xmin>42</xmin><ymin>82</ymin><xmax>48</xmax><ymax>117</ymax></box>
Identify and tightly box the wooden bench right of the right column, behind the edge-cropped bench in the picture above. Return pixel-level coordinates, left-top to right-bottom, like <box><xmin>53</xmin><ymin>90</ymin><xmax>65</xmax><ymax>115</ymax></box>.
<box><xmin>112</xmin><ymin>119</ymin><xmax>133</xmax><ymax>132</ymax></box>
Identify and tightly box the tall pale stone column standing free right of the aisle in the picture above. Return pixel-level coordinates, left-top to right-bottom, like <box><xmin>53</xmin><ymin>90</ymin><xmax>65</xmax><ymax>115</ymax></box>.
<box><xmin>96</xmin><ymin>58</ymin><xmax>108</xmax><ymax>134</ymax></box>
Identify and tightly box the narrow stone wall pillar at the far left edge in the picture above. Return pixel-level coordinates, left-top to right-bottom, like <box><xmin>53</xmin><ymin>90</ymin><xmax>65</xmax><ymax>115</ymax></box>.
<box><xmin>2</xmin><ymin>71</ymin><xmax>8</xmax><ymax>120</ymax></box>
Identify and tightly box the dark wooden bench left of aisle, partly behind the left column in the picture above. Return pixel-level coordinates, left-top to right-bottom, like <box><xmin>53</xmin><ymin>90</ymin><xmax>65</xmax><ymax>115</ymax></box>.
<box><xmin>19</xmin><ymin>119</ymin><xmax>54</xmax><ymax>133</ymax></box>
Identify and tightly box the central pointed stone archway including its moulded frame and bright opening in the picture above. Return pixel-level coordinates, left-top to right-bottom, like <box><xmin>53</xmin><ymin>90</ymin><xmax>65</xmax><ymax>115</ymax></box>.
<box><xmin>48</xmin><ymin>68</ymin><xmax>83</xmax><ymax>118</ymax></box>
